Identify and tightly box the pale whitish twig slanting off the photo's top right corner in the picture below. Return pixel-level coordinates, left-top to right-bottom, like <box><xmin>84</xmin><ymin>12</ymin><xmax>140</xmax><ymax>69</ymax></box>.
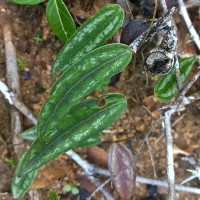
<box><xmin>178</xmin><ymin>0</ymin><xmax>200</xmax><ymax>50</ymax></box>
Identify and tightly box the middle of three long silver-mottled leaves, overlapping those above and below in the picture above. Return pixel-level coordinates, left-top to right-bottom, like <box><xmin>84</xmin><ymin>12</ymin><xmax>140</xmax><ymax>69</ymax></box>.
<box><xmin>37</xmin><ymin>44</ymin><xmax>132</xmax><ymax>141</ymax></box>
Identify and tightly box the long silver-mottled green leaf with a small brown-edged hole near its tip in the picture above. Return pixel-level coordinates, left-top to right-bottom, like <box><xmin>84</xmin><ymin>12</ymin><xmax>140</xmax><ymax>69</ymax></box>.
<box><xmin>18</xmin><ymin>94</ymin><xmax>127</xmax><ymax>177</ymax></box>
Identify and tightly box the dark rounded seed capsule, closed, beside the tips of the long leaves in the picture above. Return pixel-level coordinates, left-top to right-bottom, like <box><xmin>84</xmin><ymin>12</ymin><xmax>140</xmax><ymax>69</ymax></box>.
<box><xmin>120</xmin><ymin>19</ymin><xmax>150</xmax><ymax>45</ymax></box>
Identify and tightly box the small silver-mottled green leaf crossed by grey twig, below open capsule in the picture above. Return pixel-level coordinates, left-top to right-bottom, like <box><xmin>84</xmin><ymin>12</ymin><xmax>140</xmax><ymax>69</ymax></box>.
<box><xmin>154</xmin><ymin>56</ymin><xmax>196</xmax><ymax>102</ymax></box>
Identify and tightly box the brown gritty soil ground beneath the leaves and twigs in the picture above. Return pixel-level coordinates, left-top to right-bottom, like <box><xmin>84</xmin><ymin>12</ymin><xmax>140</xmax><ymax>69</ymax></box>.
<box><xmin>0</xmin><ymin>0</ymin><xmax>200</xmax><ymax>200</ymax></box>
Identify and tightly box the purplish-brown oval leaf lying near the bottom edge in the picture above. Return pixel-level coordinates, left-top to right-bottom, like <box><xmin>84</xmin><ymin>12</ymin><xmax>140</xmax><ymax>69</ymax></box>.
<box><xmin>108</xmin><ymin>144</ymin><xmax>136</xmax><ymax>200</ymax></box>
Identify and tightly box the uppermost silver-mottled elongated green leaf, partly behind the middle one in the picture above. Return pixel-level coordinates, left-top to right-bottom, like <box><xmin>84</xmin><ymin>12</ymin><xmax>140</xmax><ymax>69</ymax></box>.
<box><xmin>53</xmin><ymin>4</ymin><xmax>124</xmax><ymax>78</ymax></box>
